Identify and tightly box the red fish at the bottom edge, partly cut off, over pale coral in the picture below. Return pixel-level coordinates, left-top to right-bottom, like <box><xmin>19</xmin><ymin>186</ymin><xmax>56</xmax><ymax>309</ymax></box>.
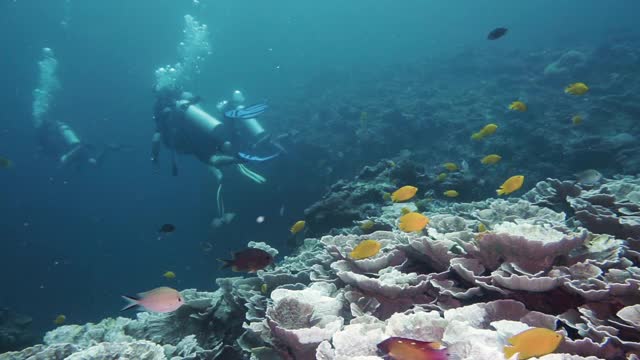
<box><xmin>378</xmin><ymin>337</ymin><xmax>448</xmax><ymax>360</ymax></box>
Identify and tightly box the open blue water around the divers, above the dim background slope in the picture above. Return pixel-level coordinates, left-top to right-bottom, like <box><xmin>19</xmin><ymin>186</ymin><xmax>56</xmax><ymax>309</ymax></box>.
<box><xmin>0</xmin><ymin>0</ymin><xmax>640</xmax><ymax>344</ymax></box>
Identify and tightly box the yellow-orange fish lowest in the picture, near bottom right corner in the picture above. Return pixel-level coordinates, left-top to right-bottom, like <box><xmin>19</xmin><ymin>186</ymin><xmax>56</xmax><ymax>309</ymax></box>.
<box><xmin>504</xmin><ymin>328</ymin><xmax>564</xmax><ymax>360</ymax></box>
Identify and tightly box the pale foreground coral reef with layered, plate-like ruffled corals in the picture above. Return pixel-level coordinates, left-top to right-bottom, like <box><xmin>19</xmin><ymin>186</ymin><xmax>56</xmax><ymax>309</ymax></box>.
<box><xmin>5</xmin><ymin>167</ymin><xmax>640</xmax><ymax>360</ymax></box>
